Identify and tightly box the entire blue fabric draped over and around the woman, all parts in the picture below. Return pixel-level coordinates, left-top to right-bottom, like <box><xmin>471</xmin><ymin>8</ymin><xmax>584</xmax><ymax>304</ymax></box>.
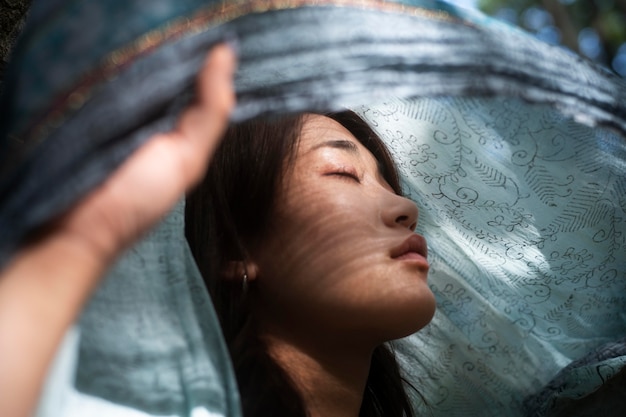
<box><xmin>0</xmin><ymin>0</ymin><xmax>626</xmax><ymax>416</ymax></box>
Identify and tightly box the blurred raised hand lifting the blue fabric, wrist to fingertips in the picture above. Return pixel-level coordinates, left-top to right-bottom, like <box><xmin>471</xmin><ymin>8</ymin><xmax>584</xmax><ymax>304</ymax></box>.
<box><xmin>54</xmin><ymin>45</ymin><xmax>235</xmax><ymax>260</ymax></box>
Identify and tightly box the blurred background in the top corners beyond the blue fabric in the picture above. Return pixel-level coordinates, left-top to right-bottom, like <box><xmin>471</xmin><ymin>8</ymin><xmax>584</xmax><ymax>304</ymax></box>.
<box><xmin>0</xmin><ymin>0</ymin><xmax>626</xmax><ymax>83</ymax></box>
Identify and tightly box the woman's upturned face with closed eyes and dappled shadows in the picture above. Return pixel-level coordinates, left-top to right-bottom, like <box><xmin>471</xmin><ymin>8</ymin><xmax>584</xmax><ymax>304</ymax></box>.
<box><xmin>252</xmin><ymin>115</ymin><xmax>435</xmax><ymax>344</ymax></box>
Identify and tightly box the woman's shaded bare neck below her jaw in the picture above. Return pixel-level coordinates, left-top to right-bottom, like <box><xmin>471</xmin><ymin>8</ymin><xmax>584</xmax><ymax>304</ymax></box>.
<box><xmin>266</xmin><ymin>336</ymin><xmax>372</xmax><ymax>417</ymax></box>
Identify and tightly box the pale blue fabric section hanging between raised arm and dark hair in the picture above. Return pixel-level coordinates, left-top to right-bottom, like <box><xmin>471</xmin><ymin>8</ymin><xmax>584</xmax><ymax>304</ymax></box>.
<box><xmin>39</xmin><ymin>203</ymin><xmax>240</xmax><ymax>417</ymax></box>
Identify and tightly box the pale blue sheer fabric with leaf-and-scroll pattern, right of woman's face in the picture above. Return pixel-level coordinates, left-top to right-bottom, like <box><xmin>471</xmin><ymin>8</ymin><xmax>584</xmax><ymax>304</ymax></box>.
<box><xmin>360</xmin><ymin>98</ymin><xmax>626</xmax><ymax>416</ymax></box>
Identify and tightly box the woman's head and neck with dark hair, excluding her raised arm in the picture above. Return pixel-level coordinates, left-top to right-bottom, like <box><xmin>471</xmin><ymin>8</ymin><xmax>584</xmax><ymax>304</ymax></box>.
<box><xmin>186</xmin><ymin>112</ymin><xmax>435</xmax><ymax>416</ymax></box>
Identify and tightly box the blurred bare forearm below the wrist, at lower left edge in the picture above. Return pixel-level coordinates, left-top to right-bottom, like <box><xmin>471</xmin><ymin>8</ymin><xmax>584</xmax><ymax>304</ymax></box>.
<box><xmin>0</xmin><ymin>235</ymin><xmax>107</xmax><ymax>417</ymax></box>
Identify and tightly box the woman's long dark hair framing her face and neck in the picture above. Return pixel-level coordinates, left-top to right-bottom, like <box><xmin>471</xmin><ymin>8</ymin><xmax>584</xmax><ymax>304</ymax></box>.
<box><xmin>185</xmin><ymin>111</ymin><xmax>413</xmax><ymax>417</ymax></box>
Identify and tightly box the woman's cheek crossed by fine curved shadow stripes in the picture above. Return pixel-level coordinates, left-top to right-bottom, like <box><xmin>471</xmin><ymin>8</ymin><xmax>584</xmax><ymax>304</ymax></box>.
<box><xmin>264</xmin><ymin>191</ymin><xmax>382</xmax><ymax>296</ymax></box>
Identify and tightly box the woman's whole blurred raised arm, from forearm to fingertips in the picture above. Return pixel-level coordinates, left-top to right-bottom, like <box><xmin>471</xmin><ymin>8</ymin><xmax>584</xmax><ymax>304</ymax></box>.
<box><xmin>0</xmin><ymin>46</ymin><xmax>235</xmax><ymax>417</ymax></box>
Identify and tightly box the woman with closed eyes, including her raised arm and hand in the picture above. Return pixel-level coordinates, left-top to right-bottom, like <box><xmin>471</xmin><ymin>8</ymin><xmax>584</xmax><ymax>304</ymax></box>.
<box><xmin>0</xmin><ymin>48</ymin><xmax>434</xmax><ymax>416</ymax></box>
